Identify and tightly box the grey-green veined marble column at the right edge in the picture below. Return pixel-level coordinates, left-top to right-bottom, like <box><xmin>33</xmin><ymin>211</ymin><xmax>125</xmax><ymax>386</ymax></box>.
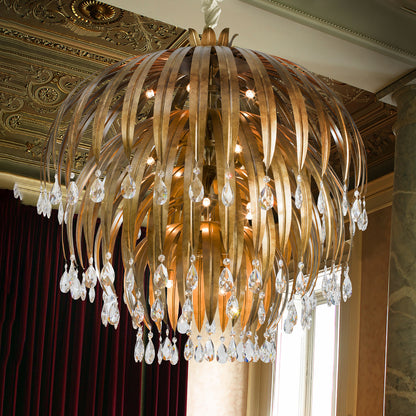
<box><xmin>384</xmin><ymin>85</ymin><xmax>416</xmax><ymax>416</ymax></box>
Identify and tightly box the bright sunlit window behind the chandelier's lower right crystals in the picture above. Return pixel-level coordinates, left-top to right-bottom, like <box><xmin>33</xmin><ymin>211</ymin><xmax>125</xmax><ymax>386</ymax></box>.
<box><xmin>272</xmin><ymin>276</ymin><xmax>340</xmax><ymax>416</ymax></box>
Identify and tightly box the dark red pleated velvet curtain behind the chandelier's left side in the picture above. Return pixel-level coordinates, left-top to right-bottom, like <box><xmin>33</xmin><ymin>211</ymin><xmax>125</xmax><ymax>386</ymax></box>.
<box><xmin>0</xmin><ymin>190</ymin><xmax>187</xmax><ymax>416</ymax></box>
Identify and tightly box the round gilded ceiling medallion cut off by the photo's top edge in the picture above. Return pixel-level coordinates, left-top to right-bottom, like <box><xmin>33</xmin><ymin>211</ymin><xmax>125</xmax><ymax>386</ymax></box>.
<box><xmin>71</xmin><ymin>0</ymin><xmax>123</xmax><ymax>25</ymax></box>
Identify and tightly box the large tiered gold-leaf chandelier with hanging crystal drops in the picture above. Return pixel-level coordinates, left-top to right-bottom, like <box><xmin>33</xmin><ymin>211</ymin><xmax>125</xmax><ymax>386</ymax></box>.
<box><xmin>38</xmin><ymin>14</ymin><xmax>368</xmax><ymax>364</ymax></box>
